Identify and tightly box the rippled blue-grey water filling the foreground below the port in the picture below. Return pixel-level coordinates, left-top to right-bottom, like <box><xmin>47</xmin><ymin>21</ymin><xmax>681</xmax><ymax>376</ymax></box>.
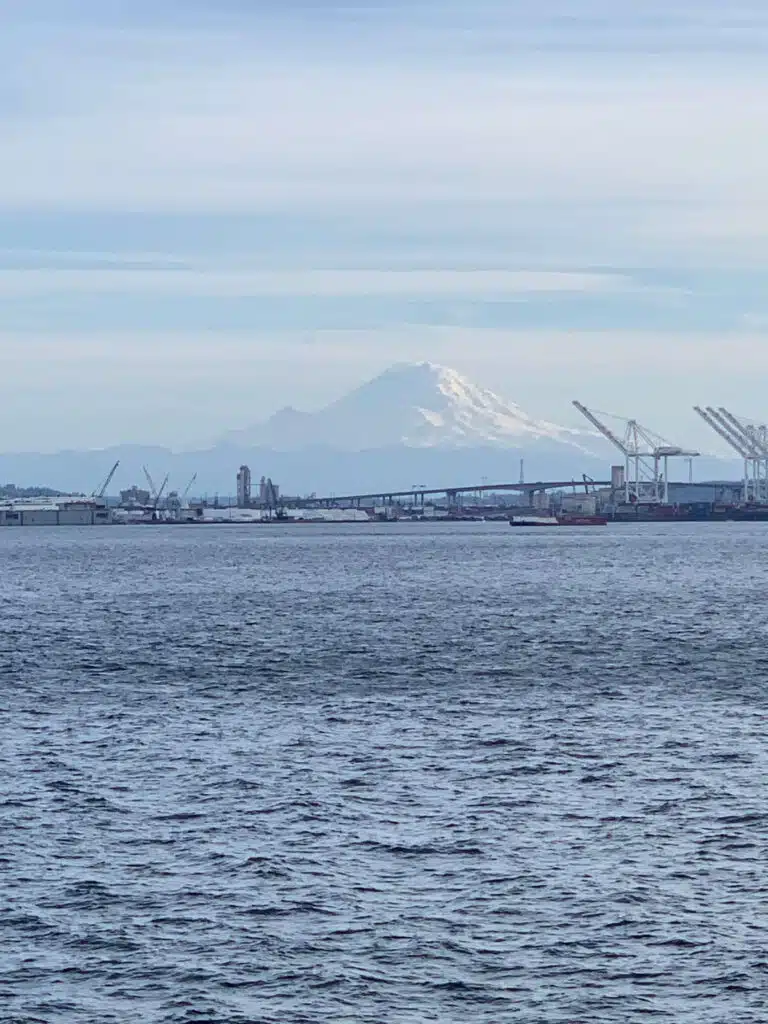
<box><xmin>0</xmin><ymin>523</ymin><xmax>768</xmax><ymax>1024</ymax></box>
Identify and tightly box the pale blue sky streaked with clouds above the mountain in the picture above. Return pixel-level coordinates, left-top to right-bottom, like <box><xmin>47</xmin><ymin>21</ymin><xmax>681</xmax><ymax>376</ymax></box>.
<box><xmin>0</xmin><ymin>0</ymin><xmax>768</xmax><ymax>451</ymax></box>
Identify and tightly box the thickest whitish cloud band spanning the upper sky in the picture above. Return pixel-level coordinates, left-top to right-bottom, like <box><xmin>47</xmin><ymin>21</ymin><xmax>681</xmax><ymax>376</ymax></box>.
<box><xmin>6</xmin><ymin>68</ymin><xmax>768</xmax><ymax>217</ymax></box>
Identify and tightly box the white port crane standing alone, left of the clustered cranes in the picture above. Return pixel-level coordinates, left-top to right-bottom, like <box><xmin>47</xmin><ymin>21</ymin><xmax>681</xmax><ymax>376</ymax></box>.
<box><xmin>573</xmin><ymin>399</ymin><xmax>699</xmax><ymax>504</ymax></box>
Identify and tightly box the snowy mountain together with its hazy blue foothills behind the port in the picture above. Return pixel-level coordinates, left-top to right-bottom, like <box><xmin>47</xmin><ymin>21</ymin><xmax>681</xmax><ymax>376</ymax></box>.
<box><xmin>0</xmin><ymin>362</ymin><xmax>738</xmax><ymax>497</ymax></box>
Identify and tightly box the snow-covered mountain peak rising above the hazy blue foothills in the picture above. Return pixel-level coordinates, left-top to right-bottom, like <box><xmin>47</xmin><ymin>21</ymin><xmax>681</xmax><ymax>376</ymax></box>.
<box><xmin>226</xmin><ymin>362</ymin><xmax>600</xmax><ymax>455</ymax></box>
